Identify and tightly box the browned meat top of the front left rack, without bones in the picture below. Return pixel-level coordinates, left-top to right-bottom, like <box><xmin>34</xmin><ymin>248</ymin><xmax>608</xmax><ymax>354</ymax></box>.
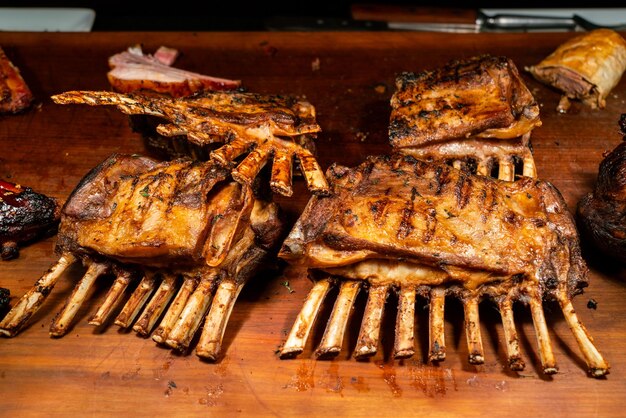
<box><xmin>58</xmin><ymin>155</ymin><xmax>253</xmax><ymax>266</ymax></box>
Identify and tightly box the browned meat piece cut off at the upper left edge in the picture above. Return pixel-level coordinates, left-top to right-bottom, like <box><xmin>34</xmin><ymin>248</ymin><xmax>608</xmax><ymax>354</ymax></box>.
<box><xmin>0</xmin><ymin>48</ymin><xmax>33</xmax><ymax>114</ymax></box>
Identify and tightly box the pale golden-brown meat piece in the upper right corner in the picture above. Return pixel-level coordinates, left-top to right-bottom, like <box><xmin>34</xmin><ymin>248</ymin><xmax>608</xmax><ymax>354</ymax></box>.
<box><xmin>526</xmin><ymin>29</ymin><xmax>626</xmax><ymax>113</ymax></box>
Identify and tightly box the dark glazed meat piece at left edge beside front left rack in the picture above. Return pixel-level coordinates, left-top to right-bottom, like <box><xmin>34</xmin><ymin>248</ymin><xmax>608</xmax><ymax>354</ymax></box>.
<box><xmin>0</xmin><ymin>180</ymin><xmax>60</xmax><ymax>260</ymax></box>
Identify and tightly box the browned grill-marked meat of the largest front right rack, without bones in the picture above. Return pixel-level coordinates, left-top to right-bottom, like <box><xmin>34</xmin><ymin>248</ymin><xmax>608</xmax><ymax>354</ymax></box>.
<box><xmin>279</xmin><ymin>155</ymin><xmax>587</xmax><ymax>295</ymax></box>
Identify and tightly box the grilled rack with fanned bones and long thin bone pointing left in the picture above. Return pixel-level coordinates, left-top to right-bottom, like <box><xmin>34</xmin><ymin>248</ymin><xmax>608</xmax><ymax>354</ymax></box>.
<box><xmin>52</xmin><ymin>91</ymin><xmax>328</xmax><ymax>196</ymax></box>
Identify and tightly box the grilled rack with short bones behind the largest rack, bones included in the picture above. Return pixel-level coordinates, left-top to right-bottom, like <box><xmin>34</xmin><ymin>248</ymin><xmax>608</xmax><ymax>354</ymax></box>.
<box><xmin>389</xmin><ymin>55</ymin><xmax>541</xmax><ymax>180</ymax></box>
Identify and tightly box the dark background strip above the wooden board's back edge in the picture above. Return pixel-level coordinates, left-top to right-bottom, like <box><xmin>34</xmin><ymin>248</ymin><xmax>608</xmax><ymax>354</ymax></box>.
<box><xmin>0</xmin><ymin>0</ymin><xmax>625</xmax><ymax>31</ymax></box>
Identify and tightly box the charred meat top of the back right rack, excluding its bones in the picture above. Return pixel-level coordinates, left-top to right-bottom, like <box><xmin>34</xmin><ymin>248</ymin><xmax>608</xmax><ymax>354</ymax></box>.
<box><xmin>389</xmin><ymin>55</ymin><xmax>541</xmax><ymax>148</ymax></box>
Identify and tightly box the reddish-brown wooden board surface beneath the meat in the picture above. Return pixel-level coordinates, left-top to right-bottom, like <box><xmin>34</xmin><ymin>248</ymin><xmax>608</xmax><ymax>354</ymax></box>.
<box><xmin>0</xmin><ymin>32</ymin><xmax>626</xmax><ymax>417</ymax></box>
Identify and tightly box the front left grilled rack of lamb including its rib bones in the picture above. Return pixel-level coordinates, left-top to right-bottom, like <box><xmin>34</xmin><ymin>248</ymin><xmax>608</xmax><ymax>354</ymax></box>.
<box><xmin>0</xmin><ymin>155</ymin><xmax>284</xmax><ymax>360</ymax></box>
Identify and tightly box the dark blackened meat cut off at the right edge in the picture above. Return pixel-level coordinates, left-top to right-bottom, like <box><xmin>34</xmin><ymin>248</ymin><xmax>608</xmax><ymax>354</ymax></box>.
<box><xmin>576</xmin><ymin>114</ymin><xmax>626</xmax><ymax>263</ymax></box>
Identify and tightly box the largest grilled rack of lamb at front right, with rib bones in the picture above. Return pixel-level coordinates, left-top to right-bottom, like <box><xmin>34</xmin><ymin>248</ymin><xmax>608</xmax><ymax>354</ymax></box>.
<box><xmin>279</xmin><ymin>154</ymin><xmax>609</xmax><ymax>377</ymax></box>
